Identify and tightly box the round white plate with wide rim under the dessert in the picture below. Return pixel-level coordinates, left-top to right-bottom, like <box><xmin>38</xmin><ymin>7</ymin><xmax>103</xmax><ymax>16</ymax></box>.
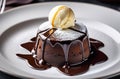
<box><xmin>0</xmin><ymin>2</ymin><xmax>120</xmax><ymax>79</ymax></box>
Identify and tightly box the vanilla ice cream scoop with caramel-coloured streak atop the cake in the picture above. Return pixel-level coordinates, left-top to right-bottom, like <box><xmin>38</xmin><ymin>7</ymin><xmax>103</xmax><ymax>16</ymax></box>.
<box><xmin>48</xmin><ymin>5</ymin><xmax>75</xmax><ymax>29</ymax></box>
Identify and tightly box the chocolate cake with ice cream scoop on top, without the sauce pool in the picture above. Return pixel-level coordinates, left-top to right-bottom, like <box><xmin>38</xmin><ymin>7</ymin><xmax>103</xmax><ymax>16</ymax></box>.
<box><xmin>35</xmin><ymin>5</ymin><xmax>90</xmax><ymax>67</ymax></box>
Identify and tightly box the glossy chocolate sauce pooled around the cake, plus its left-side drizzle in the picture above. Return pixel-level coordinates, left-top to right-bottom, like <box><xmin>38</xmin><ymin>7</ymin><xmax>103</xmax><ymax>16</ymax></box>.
<box><xmin>16</xmin><ymin>29</ymin><xmax>108</xmax><ymax>76</ymax></box>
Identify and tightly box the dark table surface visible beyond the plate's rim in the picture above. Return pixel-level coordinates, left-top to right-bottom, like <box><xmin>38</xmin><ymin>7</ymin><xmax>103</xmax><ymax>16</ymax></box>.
<box><xmin>0</xmin><ymin>0</ymin><xmax>120</xmax><ymax>79</ymax></box>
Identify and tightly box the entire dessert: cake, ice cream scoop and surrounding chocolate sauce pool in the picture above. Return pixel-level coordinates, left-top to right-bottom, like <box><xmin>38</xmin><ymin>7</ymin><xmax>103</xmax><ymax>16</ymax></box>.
<box><xmin>17</xmin><ymin>5</ymin><xmax>108</xmax><ymax>75</ymax></box>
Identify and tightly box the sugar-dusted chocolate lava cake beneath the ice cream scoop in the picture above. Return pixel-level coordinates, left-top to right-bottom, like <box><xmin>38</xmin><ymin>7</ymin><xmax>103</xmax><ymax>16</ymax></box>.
<box><xmin>35</xmin><ymin>22</ymin><xmax>90</xmax><ymax>66</ymax></box>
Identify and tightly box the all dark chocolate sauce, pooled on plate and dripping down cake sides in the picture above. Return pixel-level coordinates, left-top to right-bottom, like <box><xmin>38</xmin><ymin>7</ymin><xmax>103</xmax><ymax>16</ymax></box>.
<box><xmin>17</xmin><ymin>29</ymin><xmax>108</xmax><ymax>76</ymax></box>
